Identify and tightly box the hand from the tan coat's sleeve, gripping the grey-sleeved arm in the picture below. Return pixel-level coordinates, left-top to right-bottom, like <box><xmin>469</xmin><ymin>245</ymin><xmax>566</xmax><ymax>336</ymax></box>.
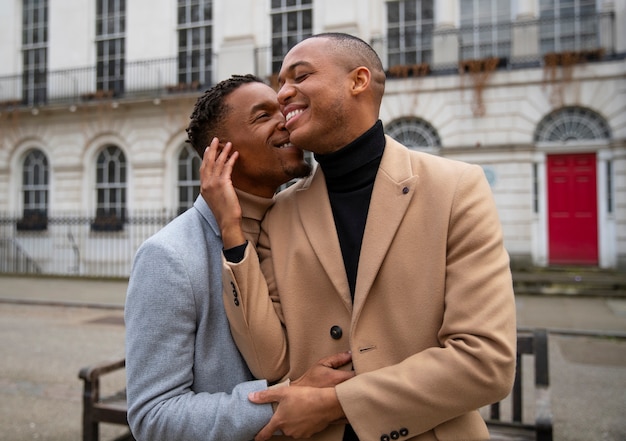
<box><xmin>248</xmin><ymin>386</ymin><xmax>345</xmax><ymax>441</ymax></box>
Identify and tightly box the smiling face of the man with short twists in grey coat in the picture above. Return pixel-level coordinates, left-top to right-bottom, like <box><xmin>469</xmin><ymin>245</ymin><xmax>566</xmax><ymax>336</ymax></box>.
<box><xmin>220</xmin><ymin>82</ymin><xmax>310</xmax><ymax>197</ymax></box>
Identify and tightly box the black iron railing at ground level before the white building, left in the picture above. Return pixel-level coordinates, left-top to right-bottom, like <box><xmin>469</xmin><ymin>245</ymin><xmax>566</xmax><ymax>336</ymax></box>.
<box><xmin>0</xmin><ymin>212</ymin><xmax>175</xmax><ymax>277</ymax></box>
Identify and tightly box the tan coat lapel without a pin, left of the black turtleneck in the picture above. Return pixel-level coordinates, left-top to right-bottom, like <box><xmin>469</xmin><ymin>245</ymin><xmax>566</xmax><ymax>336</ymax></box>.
<box><xmin>296</xmin><ymin>167</ymin><xmax>352</xmax><ymax>311</ymax></box>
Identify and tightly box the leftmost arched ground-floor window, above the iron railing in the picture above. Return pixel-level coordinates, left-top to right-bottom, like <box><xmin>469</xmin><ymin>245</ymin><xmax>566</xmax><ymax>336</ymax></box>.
<box><xmin>17</xmin><ymin>150</ymin><xmax>49</xmax><ymax>231</ymax></box>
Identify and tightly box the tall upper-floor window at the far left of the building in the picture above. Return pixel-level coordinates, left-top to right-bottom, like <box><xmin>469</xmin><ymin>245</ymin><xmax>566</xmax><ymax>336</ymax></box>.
<box><xmin>22</xmin><ymin>0</ymin><xmax>48</xmax><ymax>104</ymax></box>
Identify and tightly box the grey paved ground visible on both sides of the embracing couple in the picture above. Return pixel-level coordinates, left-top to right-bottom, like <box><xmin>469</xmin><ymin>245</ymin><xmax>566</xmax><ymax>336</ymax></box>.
<box><xmin>0</xmin><ymin>276</ymin><xmax>626</xmax><ymax>441</ymax></box>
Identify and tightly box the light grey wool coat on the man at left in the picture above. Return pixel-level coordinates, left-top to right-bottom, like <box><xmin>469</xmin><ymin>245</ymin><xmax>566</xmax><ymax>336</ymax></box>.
<box><xmin>125</xmin><ymin>197</ymin><xmax>272</xmax><ymax>441</ymax></box>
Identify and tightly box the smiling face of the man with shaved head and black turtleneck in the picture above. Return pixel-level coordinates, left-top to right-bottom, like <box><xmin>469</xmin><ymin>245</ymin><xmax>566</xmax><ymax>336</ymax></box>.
<box><xmin>278</xmin><ymin>37</ymin><xmax>378</xmax><ymax>154</ymax></box>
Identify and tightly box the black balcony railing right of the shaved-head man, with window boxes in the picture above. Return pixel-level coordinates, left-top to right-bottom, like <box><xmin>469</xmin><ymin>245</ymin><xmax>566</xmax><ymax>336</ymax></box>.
<box><xmin>371</xmin><ymin>12</ymin><xmax>624</xmax><ymax>78</ymax></box>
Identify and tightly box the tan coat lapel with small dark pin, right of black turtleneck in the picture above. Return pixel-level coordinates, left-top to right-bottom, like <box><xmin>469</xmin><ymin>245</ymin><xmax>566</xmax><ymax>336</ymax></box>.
<box><xmin>353</xmin><ymin>137</ymin><xmax>418</xmax><ymax>314</ymax></box>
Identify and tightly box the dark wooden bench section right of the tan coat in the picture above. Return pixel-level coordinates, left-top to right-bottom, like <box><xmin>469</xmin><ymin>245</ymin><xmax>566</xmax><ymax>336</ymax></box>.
<box><xmin>485</xmin><ymin>329</ymin><xmax>552</xmax><ymax>441</ymax></box>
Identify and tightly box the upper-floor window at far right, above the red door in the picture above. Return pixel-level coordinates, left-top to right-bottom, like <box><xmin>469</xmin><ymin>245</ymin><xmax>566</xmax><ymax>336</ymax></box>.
<box><xmin>539</xmin><ymin>0</ymin><xmax>599</xmax><ymax>55</ymax></box>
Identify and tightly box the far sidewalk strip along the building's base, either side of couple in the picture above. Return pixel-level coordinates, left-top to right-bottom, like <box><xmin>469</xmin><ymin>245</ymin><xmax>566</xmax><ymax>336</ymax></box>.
<box><xmin>0</xmin><ymin>276</ymin><xmax>626</xmax><ymax>338</ymax></box>
